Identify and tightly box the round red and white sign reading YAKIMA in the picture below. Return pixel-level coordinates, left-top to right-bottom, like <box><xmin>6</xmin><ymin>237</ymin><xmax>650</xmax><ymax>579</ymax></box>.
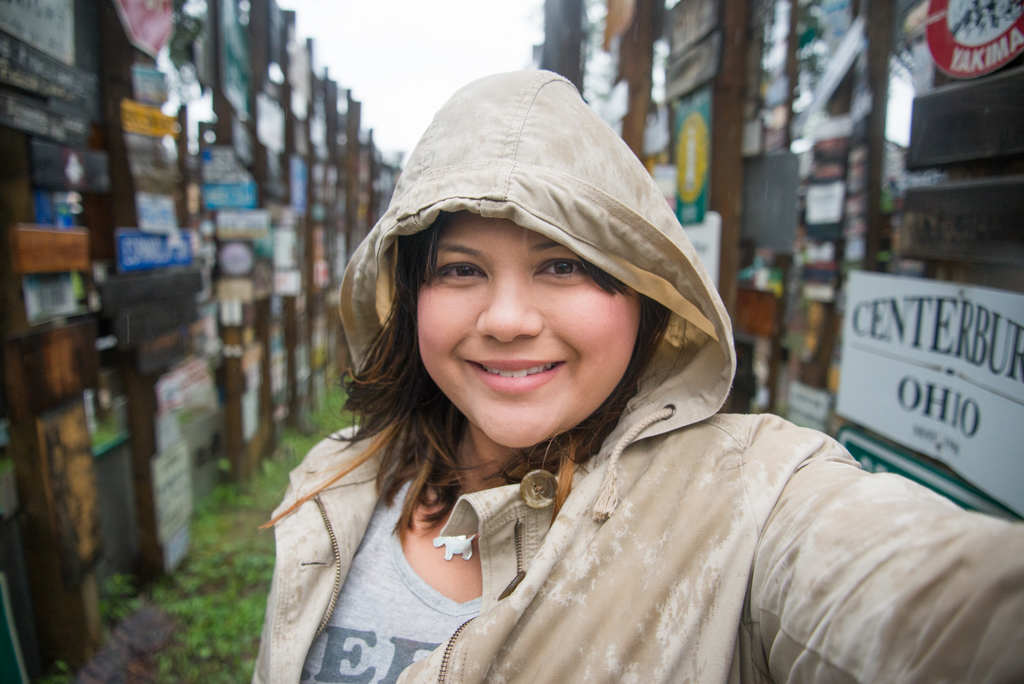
<box><xmin>928</xmin><ymin>0</ymin><xmax>1024</xmax><ymax>79</ymax></box>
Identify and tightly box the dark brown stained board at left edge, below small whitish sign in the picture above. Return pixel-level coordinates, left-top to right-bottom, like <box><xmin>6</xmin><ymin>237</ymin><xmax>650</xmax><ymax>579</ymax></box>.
<box><xmin>4</xmin><ymin>317</ymin><xmax>97</xmax><ymax>420</ymax></box>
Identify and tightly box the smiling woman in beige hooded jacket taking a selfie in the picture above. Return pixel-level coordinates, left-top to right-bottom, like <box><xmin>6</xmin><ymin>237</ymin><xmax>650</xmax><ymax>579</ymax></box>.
<box><xmin>254</xmin><ymin>72</ymin><xmax>1024</xmax><ymax>682</ymax></box>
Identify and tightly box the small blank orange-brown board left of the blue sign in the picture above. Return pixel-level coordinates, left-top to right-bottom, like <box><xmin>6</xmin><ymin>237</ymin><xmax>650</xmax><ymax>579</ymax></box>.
<box><xmin>8</xmin><ymin>223</ymin><xmax>91</xmax><ymax>275</ymax></box>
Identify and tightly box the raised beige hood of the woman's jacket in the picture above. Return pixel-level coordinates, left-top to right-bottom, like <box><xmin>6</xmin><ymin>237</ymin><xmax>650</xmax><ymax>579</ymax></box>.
<box><xmin>341</xmin><ymin>71</ymin><xmax>735</xmax><ymax>438</ymax></box>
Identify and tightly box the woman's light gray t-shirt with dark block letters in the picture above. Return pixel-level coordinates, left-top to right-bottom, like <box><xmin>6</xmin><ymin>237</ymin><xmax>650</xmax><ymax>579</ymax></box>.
<box><xmin>301</xmin><ymin>483</ymin><xmax>480</xmax><ymax>684</ymax></box>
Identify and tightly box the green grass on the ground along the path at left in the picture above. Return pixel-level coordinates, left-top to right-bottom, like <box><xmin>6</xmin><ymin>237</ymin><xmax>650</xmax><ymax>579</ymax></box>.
<box><xmin>36</xmin><ymin>389</ymin><xmax>347</xmax><ymax>684</ymax></box>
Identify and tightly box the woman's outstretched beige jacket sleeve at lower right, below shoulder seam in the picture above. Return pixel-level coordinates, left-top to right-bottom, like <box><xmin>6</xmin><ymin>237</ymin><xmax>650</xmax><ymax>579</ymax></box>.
<box><xmin>750</xmin><ymin>440</ymin><xmax>1024</xmax><ymax>682</ymax></box>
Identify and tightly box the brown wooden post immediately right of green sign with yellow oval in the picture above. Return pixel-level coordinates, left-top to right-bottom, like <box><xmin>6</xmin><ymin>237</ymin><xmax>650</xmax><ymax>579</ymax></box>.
<box><xmin>709</xmin><ymin>0</ymin><xmax>748</xmax><ymax>315</ymax></box>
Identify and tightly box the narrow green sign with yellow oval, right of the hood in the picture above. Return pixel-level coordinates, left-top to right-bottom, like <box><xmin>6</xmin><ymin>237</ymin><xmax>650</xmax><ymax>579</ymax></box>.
<box><xmin>676</xmin><ymin>86</ymin><xmax>711</xmax><ymax>225</ymax></box>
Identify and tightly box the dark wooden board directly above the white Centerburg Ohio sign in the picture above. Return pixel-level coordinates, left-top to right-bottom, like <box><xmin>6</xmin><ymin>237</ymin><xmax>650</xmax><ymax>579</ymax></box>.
<box><xmin>899</xmin><ymin>176</ymin><xmax>1024</xmax><ymax>265</ymax></box>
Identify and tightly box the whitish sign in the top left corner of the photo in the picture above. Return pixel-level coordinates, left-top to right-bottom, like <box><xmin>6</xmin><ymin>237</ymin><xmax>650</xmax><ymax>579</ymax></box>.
<box><xmin>0</xmin><ymin>0</ymin><xmax>75</xmax><ymax>66</ymax></box>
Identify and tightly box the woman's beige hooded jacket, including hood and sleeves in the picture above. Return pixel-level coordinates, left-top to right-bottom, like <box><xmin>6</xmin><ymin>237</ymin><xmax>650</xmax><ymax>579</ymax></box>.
<box><xmin>253</xmin><ymin>71</ymin><xmax>1024</xmax><ymax>683</ymax></box>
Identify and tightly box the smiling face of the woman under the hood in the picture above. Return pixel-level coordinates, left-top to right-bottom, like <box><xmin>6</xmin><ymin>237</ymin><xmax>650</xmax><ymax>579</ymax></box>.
<box><xmin>417</xmin><ymin>213</ymin><xmax>640</xmax><ymax>456</ymax></box>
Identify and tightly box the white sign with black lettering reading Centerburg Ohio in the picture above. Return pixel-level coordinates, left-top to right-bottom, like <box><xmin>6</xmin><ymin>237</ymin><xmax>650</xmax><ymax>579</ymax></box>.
<box><xmin>836</xmin><ymin>272</ymin><xmax>1024</xmax><ymax>514</ymax></box>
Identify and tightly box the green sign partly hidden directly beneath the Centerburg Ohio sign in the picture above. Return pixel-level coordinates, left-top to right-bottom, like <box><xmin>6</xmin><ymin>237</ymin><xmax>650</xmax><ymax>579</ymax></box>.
<box><xmin>838</xmin><ymin>426</ymin><xmax>1020</xmax><ymax>520</ymax></box>
